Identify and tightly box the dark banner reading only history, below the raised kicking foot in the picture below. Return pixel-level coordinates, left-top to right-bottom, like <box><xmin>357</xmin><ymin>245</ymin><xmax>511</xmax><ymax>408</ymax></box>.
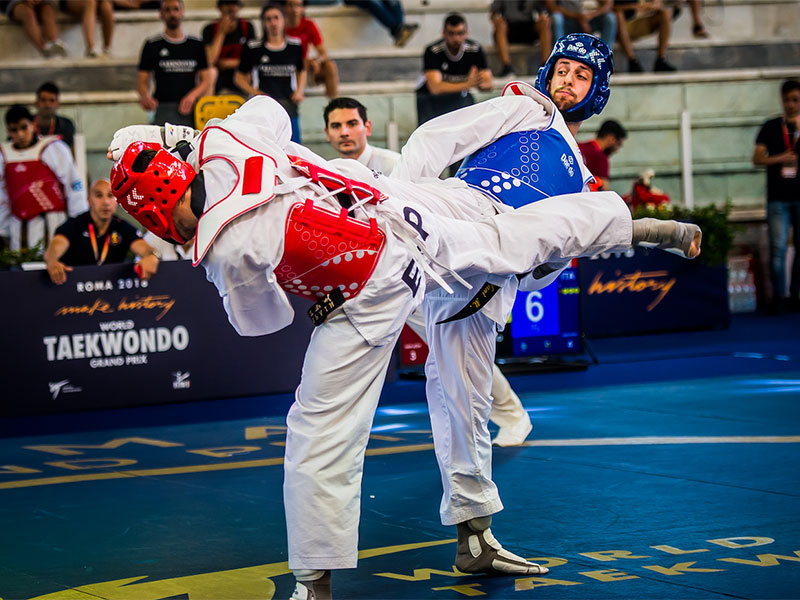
<box><xmin>579</xmin><ymin>248</ymin><xmax>730</xmax><ymax>337</ymax></box>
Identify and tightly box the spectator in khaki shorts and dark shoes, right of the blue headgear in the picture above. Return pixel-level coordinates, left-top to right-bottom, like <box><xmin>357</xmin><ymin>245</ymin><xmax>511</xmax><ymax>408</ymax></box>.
<box><xmin>614</xmin><ymin>0</ymin><xmax>677</xmax><ymax>73</ymax></box>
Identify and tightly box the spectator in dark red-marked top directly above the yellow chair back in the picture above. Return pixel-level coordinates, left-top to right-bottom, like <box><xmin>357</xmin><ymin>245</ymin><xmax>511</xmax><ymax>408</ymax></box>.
<box><xmin>203</xmin><ymin>0</ymin><xmax>256</xmax><ymax>96</ymax></box>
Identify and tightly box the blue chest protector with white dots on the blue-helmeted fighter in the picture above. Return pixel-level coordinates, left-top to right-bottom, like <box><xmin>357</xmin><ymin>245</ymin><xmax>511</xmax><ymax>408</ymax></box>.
<box><xmin>456</xmin><ymin>129</ymin><xmax>584</xmax><ymax>208</ymax></box>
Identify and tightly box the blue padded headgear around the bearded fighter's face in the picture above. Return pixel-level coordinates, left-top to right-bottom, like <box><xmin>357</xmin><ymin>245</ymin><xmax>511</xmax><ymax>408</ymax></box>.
<box><xmin>534</xmin><ymin>33</ymin><xmax>614</xmax><ymax>121</ymax></box>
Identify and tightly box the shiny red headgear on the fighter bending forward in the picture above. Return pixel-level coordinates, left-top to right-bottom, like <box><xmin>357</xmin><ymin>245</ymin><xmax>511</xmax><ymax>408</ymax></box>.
<box><xmin>111</xmin><ymin>142</ymin><xmax>197</xmax><ymax>244</ymax></box>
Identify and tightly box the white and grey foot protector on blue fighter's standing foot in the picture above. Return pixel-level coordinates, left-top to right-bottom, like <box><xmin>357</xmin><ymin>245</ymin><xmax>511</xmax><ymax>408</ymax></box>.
<box><xmin>456</xmin><ymin>519</ymin><xmax>550</xmax><ymax>575</ymax></box>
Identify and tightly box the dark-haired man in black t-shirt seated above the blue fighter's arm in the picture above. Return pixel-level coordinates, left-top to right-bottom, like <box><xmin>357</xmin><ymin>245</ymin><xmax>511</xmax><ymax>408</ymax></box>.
<box><xmin>417</xmin><ymin>13</ymin><xmax>492</xmax><ymax>125</ymax></box>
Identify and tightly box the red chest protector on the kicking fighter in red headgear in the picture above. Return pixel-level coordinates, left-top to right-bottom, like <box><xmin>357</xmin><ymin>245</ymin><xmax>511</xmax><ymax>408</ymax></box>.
<box><xmin>275</xmin><ymin>156</ymin><xmax>386</xmax><ymax>299</ymax></box>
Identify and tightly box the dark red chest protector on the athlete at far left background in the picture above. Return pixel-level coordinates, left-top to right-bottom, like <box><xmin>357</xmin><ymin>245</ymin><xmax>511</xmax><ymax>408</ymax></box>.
<box><xmin>0</xmin><ymin>138</ymin><xmax>66</xmax><ymax>221</ymax></box>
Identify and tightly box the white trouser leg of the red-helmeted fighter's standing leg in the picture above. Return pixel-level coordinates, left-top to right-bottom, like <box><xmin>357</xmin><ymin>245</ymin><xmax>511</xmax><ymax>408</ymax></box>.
<box><xmin>283</xmin><ymin>310</ymin><xmax>400</xmax><ymax>569</ymax></box>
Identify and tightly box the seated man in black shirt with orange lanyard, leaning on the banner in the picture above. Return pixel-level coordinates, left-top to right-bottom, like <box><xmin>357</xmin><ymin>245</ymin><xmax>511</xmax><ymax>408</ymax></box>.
<box><xmin>44</xmin><ymin>179</ymin><xmax>159</xmax><ymax>285</ymax></box>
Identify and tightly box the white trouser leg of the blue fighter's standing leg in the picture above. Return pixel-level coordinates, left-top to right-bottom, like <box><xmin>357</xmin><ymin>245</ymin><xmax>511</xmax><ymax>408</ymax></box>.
<box><xmin>422</xmin><ymin>280</ymin><xmax>503</xmax><ymax>525</ymax></box>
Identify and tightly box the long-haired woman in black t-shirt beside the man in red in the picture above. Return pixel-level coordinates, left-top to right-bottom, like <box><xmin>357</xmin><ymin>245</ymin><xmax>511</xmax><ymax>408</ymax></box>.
<box><xmin>233</xmin><ymin>3</ymin><xmax>306</xmax><ymax>144</ymax></box>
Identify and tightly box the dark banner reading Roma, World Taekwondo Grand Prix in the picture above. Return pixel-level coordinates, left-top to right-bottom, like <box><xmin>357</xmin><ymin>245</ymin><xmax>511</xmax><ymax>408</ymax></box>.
<box><xmin>0</xmin><ymin>261</ymin><xmax>313</xmax><ymax>416</ymax></box>
